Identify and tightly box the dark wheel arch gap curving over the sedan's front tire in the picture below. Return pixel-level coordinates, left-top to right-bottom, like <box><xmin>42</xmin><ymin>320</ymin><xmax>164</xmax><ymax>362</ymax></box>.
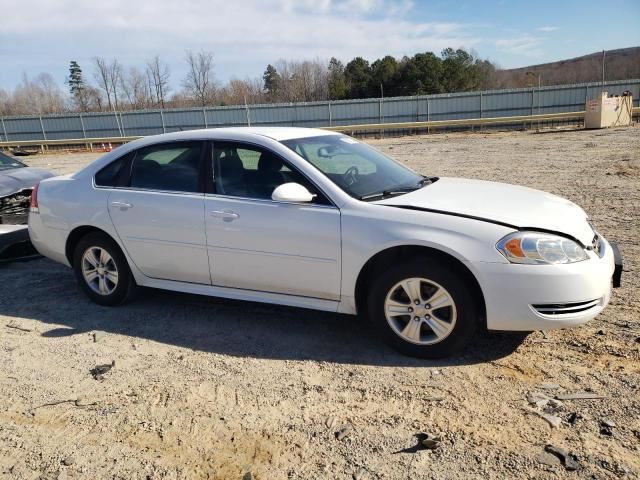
<box><xmin>354</xmin><ymin>245</ymin><xmax>486</xmax><ymax>325</ymax></box>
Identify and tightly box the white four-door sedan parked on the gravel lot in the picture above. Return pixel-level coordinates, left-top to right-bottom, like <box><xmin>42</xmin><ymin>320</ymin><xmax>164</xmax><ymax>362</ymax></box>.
<box><xmin>29</xmin><ymin>128</ymin><xmax>622</xmax><ymax>358</ymax></box>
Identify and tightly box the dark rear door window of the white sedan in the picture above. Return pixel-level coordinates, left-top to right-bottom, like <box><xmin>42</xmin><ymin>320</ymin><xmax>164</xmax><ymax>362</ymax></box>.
<box><xmin>130</xmin><ymin>142</ymin><xmax>204</xmax><ymax>193</ymax></box>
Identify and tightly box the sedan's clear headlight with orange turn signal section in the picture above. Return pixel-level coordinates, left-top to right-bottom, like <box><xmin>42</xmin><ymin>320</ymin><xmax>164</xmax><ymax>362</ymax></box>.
<box><xmin>496</xmin><ymin>232</ymin><xmax>589</xmax><ymax>265</ymax></box>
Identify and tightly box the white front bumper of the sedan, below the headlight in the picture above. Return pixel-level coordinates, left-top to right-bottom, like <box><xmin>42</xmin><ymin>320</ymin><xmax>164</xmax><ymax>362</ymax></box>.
<box><xmin>476</xmin><ymin>236</ymin><xmax>622</xmax><ymax>331</ymax></box>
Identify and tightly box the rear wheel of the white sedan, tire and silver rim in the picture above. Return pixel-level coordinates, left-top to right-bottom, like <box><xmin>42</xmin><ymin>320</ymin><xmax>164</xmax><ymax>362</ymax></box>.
<box><xmin>73</xmin><ymin>232</ymin><xmax>136</xmax><ymax>306</ymax></box>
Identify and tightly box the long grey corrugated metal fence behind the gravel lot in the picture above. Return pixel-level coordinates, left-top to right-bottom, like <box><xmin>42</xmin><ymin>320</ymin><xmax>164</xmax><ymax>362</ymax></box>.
<box><xmin>0</xmin><ymin>79</ymin><xmax>640</xmax><ymax>141</ymax></box>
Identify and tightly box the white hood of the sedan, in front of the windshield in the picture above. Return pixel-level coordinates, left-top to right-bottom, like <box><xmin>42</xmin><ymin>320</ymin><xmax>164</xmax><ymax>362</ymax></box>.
<box><xmin>375</xmin><ymin>178</ymin><xmax>594</xmax><ymax>245</ymax></box>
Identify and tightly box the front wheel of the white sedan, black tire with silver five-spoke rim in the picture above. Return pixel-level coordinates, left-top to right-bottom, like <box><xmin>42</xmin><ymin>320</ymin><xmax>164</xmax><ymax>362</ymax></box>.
<box><xmin>368</xmin><ymin>258</ymin><xmax>479</xmax><ymax>359</ymax></box>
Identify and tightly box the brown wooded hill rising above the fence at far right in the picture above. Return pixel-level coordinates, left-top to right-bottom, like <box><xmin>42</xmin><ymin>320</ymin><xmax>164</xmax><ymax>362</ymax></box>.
<box><xmin>496</xmin><ymin>47</ymin><xmax>640</xmax><ymax>88</ymax></box>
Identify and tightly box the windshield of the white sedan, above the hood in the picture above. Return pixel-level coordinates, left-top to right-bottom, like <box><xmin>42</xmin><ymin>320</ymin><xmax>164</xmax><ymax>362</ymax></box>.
<box><xmin>282</xmin><ymin>135</ymin><xmax>429</xmax><ymax>200</ymax></box>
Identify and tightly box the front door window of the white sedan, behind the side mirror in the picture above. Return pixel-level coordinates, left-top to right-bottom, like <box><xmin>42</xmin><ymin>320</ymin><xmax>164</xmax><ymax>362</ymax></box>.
<box><xmin>212</xmin><ymin>142</ymin><xmax>329</xmax><ymax>204</ymax></box>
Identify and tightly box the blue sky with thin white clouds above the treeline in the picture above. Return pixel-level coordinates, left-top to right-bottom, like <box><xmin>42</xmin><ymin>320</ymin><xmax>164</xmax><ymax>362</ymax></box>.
<box><xmin>0</xmin><ymin>0</ymin><xmax>640</xmax><ymax>90</ymax></box>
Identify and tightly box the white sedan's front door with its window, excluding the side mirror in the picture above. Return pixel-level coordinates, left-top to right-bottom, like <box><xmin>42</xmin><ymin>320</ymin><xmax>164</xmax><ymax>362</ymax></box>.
<box><xmin>204</xmin><ymin>142</ymin><xmax>341</xmax><ymax>300</ymax></box>
